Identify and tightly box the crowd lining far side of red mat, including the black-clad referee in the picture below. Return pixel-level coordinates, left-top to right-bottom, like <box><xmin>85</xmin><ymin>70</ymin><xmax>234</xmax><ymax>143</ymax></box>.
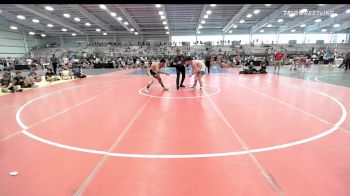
<box><xmin>0</xmin><ymin>42</ymin><xmax>350</xmax><ymax>92</ymax></box>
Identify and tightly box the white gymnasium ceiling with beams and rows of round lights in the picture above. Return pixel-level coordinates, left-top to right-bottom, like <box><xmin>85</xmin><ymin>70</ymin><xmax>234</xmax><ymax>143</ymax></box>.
<box><xmin>0</xmin><ymin>4</ymin><xmax>350</xmax><ymax>37</ymax></box>
